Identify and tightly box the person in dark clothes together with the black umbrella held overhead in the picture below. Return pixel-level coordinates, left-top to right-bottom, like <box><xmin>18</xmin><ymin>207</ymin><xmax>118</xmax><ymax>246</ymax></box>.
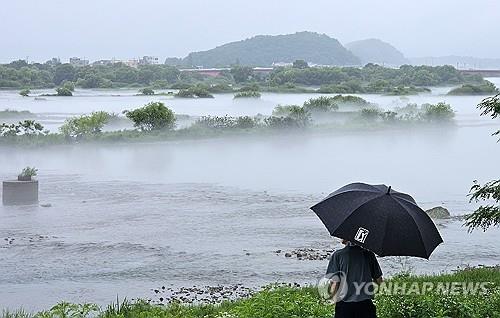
<box><xmin>311</xmin><ymin>183</ymin><xmax>443</xmax><ymax>318</ymax></box>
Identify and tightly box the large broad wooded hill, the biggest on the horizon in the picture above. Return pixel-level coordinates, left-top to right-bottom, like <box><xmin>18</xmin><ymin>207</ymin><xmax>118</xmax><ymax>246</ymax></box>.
<box><xmin>166</xmin><ymin>32</ymin><xmax>361</xmax><ymax>67</ymax></box>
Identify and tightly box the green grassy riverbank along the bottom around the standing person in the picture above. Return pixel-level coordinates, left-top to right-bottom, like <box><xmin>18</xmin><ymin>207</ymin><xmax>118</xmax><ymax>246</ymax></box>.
<box><xmin>1</xmin><ymin>267</ymin><xmax>500</xmax><ymax>318</ymax></box>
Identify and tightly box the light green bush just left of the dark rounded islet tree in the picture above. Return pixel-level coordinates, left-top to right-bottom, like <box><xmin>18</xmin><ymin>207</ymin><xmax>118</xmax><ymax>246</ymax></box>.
<box><xmin>59</xmin><ymin>111</ymin><xmax>111</xmax><ymax>139</ymax></box>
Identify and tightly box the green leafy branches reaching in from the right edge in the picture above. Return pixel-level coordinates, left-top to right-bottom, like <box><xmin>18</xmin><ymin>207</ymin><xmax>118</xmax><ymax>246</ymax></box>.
<box><xmin>465</xmin><ymin>94</ymin><xmax>500</xmax><ymax>231</ymax></box>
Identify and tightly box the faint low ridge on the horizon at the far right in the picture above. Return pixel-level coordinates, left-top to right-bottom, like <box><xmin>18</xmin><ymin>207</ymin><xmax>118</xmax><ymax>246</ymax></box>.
<box><xmin>410</xmin><ymin>55</ymin><xmax>500</xmax><ymax>69</ymax></box>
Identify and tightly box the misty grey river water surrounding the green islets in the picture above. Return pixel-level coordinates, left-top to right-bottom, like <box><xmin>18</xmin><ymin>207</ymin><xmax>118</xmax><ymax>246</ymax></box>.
<box><xmin>0</xmin><ymin>79</ymin><xmax>500</xmax><ymax>309</ymax></box>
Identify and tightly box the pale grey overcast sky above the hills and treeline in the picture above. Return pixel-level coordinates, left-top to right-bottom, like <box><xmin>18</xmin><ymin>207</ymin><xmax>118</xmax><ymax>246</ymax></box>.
<box><xmin>0</xmin><ymin>0</ymin><xmax>500</xmax><ymax>62</ymax></box>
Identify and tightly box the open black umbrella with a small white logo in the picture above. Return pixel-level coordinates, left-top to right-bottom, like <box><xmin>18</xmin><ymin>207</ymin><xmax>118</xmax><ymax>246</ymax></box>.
<box><xmin>311</xmin><ymin>183</ymin><xmax>443</xmax><ymax>258</ymax></box>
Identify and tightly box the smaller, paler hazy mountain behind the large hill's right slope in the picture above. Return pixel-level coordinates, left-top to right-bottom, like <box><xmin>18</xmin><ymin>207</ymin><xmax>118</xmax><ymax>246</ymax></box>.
<box><xmin>346</xmin><ymin>39</ymin><xmax>410</xmax><ymax>66</ymax></box>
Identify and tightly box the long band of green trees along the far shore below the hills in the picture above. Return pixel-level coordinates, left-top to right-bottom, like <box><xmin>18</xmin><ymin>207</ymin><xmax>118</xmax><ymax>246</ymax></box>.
<box><xmin>0</xmin><ymin>60</ymin><xmax>490</xmax><ymax>95</ymax></box>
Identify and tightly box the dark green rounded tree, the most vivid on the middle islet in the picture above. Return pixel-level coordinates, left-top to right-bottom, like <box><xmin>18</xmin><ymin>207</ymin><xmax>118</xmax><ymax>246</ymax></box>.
<box><xmin>124</xmin><ymin>102</ymin><xmax>175</xmax><ymax>131</ymax></box>
